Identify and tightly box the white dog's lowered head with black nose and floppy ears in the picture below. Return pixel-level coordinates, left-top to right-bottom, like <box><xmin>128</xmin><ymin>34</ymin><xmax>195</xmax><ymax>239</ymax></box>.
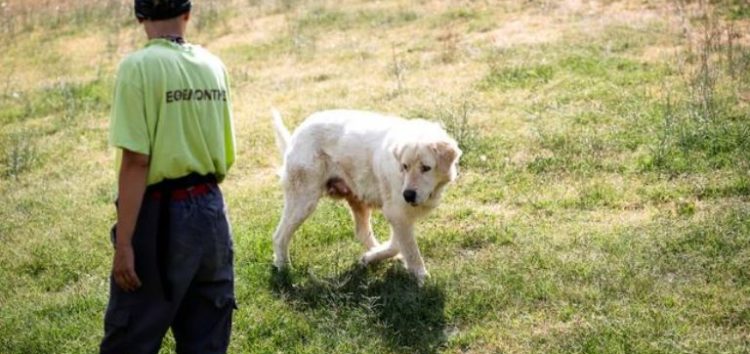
<box><xmin>393</xmin><ymin>124</ymin><xmax>461</xmax><ymax>206</ymax></box>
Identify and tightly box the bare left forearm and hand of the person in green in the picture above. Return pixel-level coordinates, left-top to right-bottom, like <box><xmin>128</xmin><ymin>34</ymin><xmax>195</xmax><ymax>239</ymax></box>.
<box><xmin>112</xmin><ymin>149</ymin><xmax>149</xmax><ymax>291</ymax></box>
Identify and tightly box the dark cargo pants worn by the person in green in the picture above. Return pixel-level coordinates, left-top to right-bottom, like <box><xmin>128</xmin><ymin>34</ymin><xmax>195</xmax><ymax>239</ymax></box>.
<box><xmin>100</xmin><ymin>185</ymin><xmax>236</xmax><ymax>354</ymax></box>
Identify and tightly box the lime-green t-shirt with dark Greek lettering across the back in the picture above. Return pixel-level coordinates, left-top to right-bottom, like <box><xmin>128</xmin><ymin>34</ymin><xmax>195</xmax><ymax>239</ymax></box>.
<box><xmin>109</xmin><ymin>39</ymin><xmax>235</xmax><ymax>185</ymax></box>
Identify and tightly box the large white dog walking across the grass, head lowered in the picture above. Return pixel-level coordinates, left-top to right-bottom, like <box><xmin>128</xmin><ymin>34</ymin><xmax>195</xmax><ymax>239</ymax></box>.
<box><xmin>273</xmin><ymin>110</ymin><xmax>461</xmax><ymax>284</ymax></box>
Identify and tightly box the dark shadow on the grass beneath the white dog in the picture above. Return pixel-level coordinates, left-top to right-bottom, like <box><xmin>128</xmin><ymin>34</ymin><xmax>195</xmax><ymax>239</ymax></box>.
<box><xmin>269</xmin><ymin>263</ymin><xmax>446</xmax><ymax>353</ymax></box>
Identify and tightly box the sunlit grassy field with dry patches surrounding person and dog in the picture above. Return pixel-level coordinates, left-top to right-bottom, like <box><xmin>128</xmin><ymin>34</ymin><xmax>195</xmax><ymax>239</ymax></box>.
<box><xmin>0</xmin><ymin>0</ymin><xmax>750</xmax><ymax>354</ymax></box>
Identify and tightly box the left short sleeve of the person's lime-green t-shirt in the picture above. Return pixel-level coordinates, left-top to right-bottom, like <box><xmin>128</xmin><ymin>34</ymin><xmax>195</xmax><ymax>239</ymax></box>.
<box><xmin>109</xmin><ymin>62</ymin><xmax>151</xmax><ymax>155</ymax></box>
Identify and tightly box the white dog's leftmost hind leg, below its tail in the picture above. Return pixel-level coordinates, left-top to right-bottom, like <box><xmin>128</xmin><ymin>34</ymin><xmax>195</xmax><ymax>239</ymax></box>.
<box><xmin>273</xmin><ymin>183</ymin><xmax>321</xmax><ymax>269</ymax></box>
